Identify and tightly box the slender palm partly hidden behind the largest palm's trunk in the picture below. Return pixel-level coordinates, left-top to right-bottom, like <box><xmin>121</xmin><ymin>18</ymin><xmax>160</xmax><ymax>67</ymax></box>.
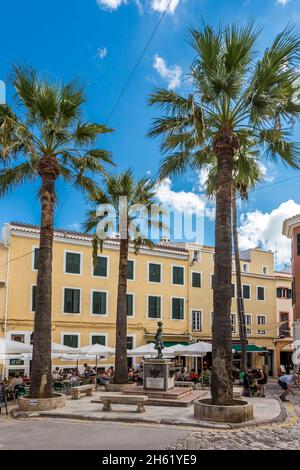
<box><xmin>206</xmin><ymin>148</ymin><xmax>262</xmax><ymax>372</ymax></box>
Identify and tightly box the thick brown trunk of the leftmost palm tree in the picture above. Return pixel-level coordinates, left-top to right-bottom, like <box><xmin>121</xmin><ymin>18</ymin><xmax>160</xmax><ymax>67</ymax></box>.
<box><xmin>30</xmin><ymin>174</ymin><xmax>55</xmax><ymax>398</ymax></box>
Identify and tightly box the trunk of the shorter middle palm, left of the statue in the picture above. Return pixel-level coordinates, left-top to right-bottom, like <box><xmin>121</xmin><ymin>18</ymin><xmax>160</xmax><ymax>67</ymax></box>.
<box><xmin>114</xmin><ymin>237</ymin><xmax>128</xmax><ymax>384</ymax></box>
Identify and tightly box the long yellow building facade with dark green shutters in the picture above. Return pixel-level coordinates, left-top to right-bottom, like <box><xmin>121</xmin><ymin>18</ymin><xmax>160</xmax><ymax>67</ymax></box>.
<box><xmin>0</xmin><ymin>223</ymin><xmax>291</xmax><ymax>375</ymax></box>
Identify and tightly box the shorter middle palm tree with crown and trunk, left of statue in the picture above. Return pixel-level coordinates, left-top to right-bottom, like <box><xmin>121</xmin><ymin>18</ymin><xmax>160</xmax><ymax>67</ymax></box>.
<box><xmin>85</xmin><ymin>170</ymin><xmax>156</xmax><ymax>384</ymax></box>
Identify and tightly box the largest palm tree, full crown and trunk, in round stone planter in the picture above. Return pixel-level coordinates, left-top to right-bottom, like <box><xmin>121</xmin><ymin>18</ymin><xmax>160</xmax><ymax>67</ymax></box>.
<box><xmin>149</xmin><ymin>23</ymin><xmax>300</xmax><ymax>404</ymax></box>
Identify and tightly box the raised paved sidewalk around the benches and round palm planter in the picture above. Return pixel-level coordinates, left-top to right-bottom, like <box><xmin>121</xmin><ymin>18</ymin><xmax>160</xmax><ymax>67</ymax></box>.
<box><xmin>14</xmin><ymin>392</ymin><xmax>286</xmax><ymax>429</ymax></box>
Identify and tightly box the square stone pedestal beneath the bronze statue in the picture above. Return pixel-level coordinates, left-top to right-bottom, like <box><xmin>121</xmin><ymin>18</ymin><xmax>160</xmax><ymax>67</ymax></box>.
<box><xmin>144</xmin><ymin>359</ymin><xmax>175</xmax><ymax>392</ymax></box>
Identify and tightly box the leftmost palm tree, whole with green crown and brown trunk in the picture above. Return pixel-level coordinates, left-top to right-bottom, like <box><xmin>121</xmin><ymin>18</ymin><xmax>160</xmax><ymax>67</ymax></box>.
<box><xmin>0</xmin><ymin>66</ymin><xmax>111</xmax><ymax>398</ymax></box>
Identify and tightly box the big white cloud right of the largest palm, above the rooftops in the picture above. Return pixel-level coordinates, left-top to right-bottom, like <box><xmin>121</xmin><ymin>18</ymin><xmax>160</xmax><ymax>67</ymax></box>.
<box><xmin>239</xmin><ymin>199</ymin><xmax>300</xmax><ymax>265</ymax></box>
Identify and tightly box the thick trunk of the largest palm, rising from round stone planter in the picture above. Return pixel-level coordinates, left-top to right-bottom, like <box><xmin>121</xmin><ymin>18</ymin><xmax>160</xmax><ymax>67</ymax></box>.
<box><xmin>211</xmin><ymin>130</ymin><xmax>237</xmax><ymax>405</ymax></box>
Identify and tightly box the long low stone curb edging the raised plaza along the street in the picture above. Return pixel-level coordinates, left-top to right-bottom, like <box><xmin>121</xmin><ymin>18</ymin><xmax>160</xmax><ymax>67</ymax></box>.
<box><xmin>11</xmin><ymin>399</ymin><xmax>288</xmax><ymax>430</ymax></box>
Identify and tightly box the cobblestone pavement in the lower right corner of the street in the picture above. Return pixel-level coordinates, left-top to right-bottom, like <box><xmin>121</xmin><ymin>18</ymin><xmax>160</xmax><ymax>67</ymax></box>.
<box><xmin>170</xmin><ymin>383</ymin><xmax>300</xmax><ymax>450</ymax></box>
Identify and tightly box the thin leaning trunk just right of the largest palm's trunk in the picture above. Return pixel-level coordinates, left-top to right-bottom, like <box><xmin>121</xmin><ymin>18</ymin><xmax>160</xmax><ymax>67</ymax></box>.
<box><xmin>231</xmin><ymin>190</ymin><xmax>247</xmax><ymax>372</ymax></box>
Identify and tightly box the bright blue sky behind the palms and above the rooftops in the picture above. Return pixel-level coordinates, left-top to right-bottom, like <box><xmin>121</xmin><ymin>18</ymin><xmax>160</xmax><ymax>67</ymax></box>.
<box><xmin>0</xmin><ymin>0</ymin><xmax>300</xmax><ymax>262</ymax></box>
